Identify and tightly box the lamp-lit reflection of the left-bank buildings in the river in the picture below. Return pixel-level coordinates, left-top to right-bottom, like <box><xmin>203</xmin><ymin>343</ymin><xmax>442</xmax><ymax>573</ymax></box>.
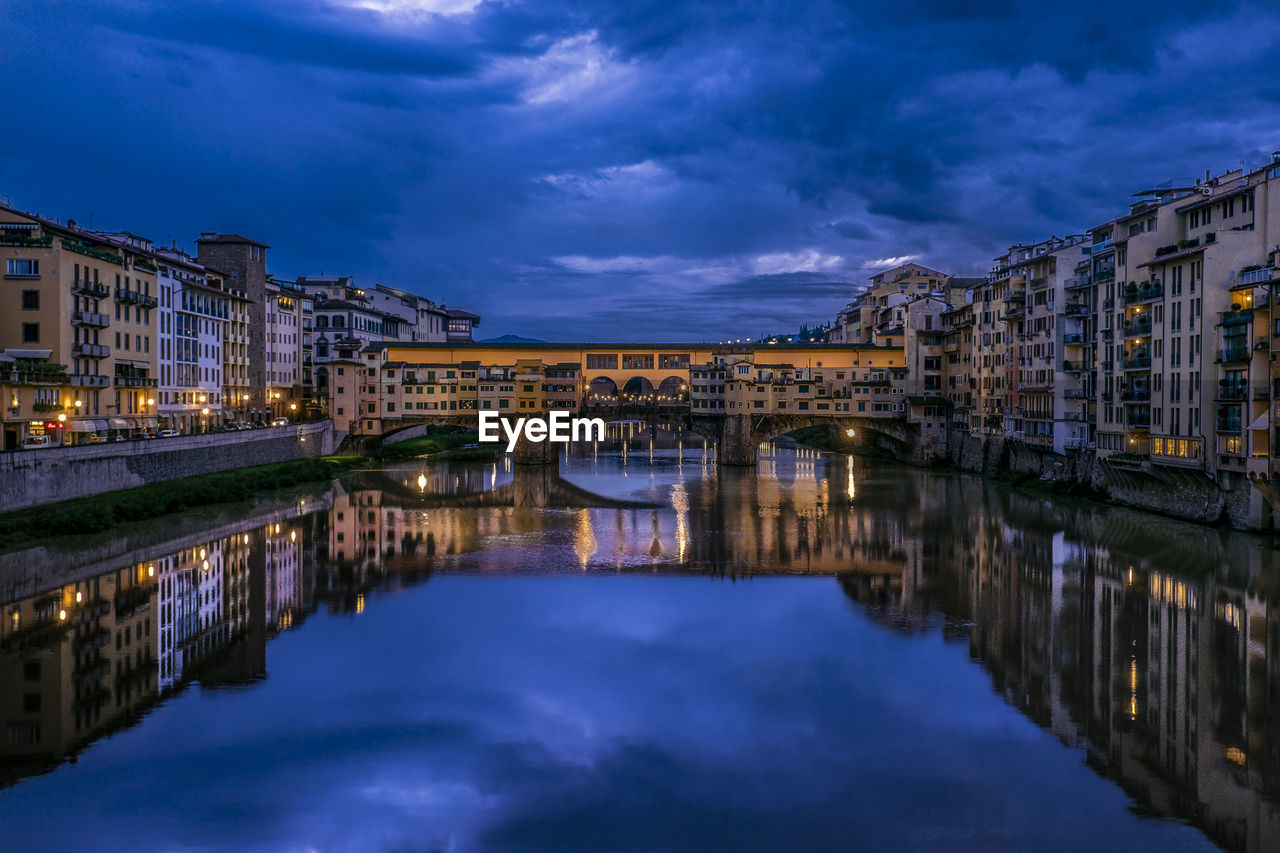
<box><xmin>0</xmin><ymin>520</ymin><xmax>306</xmax><ymax>786</ymax></box>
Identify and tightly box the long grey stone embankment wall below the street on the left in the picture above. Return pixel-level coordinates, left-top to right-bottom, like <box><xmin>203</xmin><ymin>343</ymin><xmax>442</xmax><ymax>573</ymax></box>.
<box><xmin>0</xmin><ymin>421</ymin><xmax>333</xmax><ymax>512</ymax></box>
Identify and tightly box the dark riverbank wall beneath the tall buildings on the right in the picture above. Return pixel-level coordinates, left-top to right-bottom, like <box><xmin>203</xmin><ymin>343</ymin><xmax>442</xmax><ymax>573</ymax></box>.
<box><xmin>942</xmin><ymin>434</ymin><xmax>1280</xmax><ymax>532</ymax></box>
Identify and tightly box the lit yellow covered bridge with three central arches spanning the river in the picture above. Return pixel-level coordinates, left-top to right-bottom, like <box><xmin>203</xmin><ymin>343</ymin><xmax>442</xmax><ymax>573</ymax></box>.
<box><xmin>332</xmin><ymin>342</ymin><xmax>920</xmax><ymax>465</ymax></box>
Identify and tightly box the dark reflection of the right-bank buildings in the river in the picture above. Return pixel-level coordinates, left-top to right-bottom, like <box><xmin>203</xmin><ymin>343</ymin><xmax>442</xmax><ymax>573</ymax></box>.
<box><xmin>841</xmin><ymin>478</ymin><xmax>1280</xmax><ymax>850</ymax></box>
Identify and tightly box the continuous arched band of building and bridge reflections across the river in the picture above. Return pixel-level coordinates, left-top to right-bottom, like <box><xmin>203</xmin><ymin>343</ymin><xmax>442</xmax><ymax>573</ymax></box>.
<box><xmin>0</xmin><ymin>429</ymin><xmax>1280</xmax><ymax>850</ymax></box>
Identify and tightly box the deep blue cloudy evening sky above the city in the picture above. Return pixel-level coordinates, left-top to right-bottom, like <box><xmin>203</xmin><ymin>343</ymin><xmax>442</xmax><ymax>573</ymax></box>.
<box><xmin>0</xmin><ymin>0</ymin><xmax>1280</xmax><ymax>339</ymax></box>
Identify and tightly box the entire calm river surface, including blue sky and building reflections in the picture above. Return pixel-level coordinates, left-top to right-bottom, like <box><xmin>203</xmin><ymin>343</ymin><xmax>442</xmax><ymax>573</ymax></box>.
<box><xmin>0</xmin><ymin>427</ymin><xmax>1280</xmax><ymax>850</ymax></box>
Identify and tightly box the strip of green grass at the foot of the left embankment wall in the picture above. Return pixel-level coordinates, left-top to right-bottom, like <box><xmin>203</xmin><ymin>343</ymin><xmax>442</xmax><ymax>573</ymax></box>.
<box><xmin>0</xmin><ymin>456</ymin><xmax>365</xmax><ymax>549</ymax></box>
